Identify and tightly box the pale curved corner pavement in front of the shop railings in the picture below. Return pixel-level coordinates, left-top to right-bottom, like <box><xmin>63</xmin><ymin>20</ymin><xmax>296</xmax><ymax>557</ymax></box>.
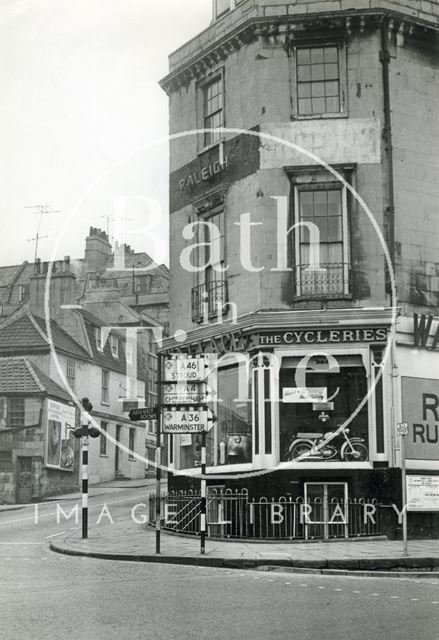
<box><xmin>46</xmin><ymin>488</ymin><xmax>439</xmax><ymax>577</ymax></box>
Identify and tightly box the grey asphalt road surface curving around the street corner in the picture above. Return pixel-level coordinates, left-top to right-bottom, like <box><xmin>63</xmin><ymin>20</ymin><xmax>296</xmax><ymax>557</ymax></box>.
<box><xmin>0</xmin><ymin>489</ymin><xmax>439</xmax><ymax>640</ymax></box>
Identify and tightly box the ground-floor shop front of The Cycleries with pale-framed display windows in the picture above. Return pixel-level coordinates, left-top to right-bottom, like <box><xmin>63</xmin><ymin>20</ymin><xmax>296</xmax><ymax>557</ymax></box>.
<box><xmin>168</xmin><ymin>312</ymin><xmax>393</xmax><ymax>538</ymax></box>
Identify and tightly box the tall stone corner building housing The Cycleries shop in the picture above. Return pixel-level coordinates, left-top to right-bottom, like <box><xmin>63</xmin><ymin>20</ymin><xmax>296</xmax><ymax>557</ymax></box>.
<box><xmin>161</xmin><ymin>0</ymin><xmax>439</xmax><ymax>537</ymax></box>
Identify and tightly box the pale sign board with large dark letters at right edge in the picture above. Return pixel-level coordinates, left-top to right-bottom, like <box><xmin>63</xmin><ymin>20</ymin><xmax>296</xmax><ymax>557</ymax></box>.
<box><xmin>401</xmin><ymin>377</ymin><xmax>439</xmax><ymax>460</ymax></box>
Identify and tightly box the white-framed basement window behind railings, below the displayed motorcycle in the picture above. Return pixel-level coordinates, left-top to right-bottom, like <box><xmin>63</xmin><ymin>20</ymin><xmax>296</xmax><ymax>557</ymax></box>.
<box><xmin>305</xmin><ymin>482</ymin><xmax>349</xmax><ymax>540</ymax></box>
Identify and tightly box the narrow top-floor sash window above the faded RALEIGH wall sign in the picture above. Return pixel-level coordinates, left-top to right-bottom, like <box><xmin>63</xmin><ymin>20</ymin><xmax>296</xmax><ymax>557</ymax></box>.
<box><xmin>199</xmin><ymin>72</ymin><xmax>225</xmax><ymax>147</ymax></box>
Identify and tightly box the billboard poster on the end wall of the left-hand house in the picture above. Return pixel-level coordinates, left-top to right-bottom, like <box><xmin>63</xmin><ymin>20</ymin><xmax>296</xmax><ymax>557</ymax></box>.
<box><xmin>46</xmin><ymin>400</ymin><xmax>76</xmax><ymax>471</ymax></box>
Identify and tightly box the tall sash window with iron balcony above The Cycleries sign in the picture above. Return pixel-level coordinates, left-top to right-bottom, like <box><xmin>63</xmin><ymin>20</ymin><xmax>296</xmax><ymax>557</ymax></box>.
<box><xmin>294</xmin><ymin>183</ymin><xmax>350</xmax><ymax>299</ymax></box>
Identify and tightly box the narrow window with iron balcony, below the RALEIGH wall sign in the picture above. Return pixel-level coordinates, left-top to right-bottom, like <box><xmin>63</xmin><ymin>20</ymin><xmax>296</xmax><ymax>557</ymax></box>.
<box><xmin>192</xmin><ymin>199</ymin><xmax>227</xmax><ymax>322</ymax></box>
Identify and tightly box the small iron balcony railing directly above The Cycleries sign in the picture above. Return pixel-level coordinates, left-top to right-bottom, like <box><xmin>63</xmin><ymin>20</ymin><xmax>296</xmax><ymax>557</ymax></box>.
<box><xmin>294</xmin><ymin>263</ymin><xmax>352</xmax><ymax>299</ymax></box>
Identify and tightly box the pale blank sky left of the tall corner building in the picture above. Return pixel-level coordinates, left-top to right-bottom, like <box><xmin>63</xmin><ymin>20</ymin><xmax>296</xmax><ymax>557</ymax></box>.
<box><xmin>0</xmin><ymin>0</ymin><xmax>211</xmax><ymax>265</ymax></box>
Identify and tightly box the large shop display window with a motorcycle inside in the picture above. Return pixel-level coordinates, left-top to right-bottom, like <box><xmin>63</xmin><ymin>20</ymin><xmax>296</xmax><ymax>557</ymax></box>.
<box><xmin>280</xmin><ymin>356</ymin><xmax>369</xmax><ymax>462</ymax></box>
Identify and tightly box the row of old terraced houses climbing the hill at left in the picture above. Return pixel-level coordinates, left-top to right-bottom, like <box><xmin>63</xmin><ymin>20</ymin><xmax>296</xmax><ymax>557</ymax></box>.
<box><xmin>0</xmin><ymin>228</ymin><xmax>168</xmax><ymax>502</ymax></box>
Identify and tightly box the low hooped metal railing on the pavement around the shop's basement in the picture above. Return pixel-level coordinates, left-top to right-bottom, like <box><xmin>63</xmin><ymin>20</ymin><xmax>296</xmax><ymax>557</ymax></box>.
<box><xmin>149</xmin><ymin>489</ymin><xmax>382</xmax><ymax>540</ymax></box>
